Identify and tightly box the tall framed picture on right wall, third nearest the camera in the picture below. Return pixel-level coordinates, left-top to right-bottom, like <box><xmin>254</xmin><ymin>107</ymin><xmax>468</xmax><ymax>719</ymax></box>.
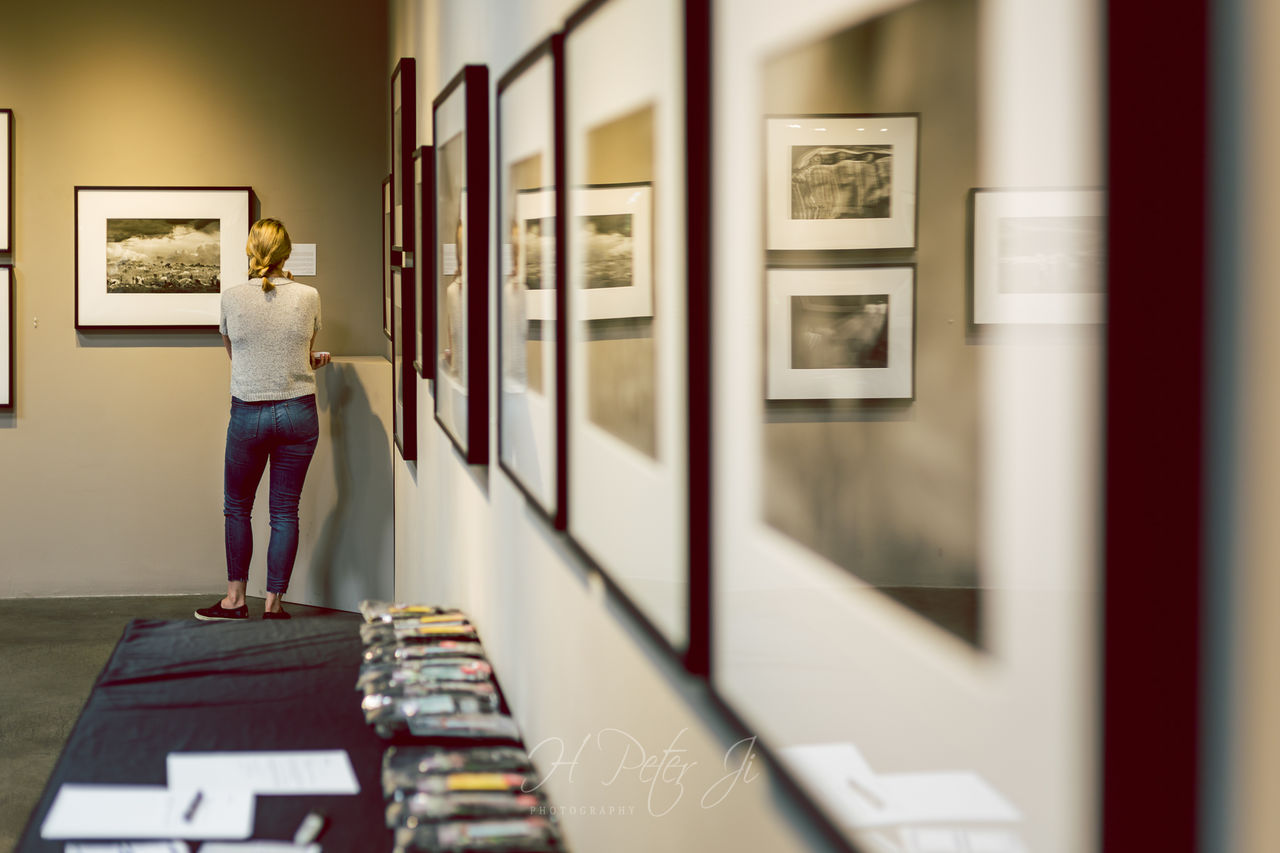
<box><xmin>497</xmin><ymin>35</ymin><xmax>566</xmax><ymax>517</ymax></box>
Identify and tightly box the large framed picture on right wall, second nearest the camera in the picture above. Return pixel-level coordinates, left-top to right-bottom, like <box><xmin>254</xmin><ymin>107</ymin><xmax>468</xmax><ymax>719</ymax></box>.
<box><xmin>565</xmin><ymin>0</ymin><xmax>707</xmax><ymax>645</ymax></box>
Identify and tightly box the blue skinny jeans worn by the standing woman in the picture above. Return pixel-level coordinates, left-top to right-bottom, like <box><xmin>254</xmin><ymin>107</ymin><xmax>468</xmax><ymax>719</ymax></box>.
<box><xmin>223</xmin><ymin>394</ymin><xmax>320</xmax><ymax>596</ymax></box>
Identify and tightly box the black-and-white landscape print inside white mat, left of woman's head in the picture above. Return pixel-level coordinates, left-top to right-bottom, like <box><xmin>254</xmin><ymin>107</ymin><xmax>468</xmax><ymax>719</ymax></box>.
<box><xmin>106</xmin><ymin>219</ymin><xmax>221</xmax><ymax>293</ymax></box>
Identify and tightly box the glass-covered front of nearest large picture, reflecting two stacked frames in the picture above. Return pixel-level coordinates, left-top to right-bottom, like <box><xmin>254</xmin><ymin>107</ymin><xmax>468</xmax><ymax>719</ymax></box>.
<box><xmin>712</xmin><ymin>0</ymin><xmax>1105</xmax><ymax>853</ymax></box>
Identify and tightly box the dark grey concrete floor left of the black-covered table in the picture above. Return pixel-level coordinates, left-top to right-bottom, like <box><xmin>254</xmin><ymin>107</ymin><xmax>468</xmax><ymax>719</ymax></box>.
<box><xmin>0</xmin><ymin>592</ymin><xmax>340</xmax><ymax>850</ymax></box>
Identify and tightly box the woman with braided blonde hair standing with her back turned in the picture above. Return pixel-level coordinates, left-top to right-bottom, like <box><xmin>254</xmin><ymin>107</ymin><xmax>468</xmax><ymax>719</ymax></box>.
<box><xmin>196</xmin><ymin>219</ymin><xmax>329</xmax><ymax>621</ymax></box>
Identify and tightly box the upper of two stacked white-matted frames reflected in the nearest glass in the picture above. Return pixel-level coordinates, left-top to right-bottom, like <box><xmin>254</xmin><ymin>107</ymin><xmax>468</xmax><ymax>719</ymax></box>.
<box><xmin>764</xmin><ymin>114</ymin><xmax>920</xmax><ymax>251</ymax></box>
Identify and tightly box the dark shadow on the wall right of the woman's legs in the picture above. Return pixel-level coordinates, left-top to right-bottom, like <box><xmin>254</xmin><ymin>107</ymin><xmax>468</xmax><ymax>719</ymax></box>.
<box><xmin>308</xmin><ymin>362</ymin><xmax>396</xmax><ymax>610</ymax></box>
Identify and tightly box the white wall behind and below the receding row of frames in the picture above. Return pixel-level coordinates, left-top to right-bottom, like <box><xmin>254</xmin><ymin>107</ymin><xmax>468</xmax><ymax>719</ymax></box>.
<box><xmin>388</xmin><ymin>0</ymin><xmax>849</xmax><ymax>853</ymax></box>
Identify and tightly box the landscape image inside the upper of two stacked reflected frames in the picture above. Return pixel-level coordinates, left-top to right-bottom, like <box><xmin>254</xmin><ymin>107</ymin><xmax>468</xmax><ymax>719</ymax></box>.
<box><xmin>791</xmin><ymin>145</ymin><xmax>893</xmax><ymax>219</ymax></box>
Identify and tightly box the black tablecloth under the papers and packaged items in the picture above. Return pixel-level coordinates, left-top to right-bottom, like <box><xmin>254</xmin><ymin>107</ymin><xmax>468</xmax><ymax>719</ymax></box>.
<box><xmin>17</xmin><ymin>613</ymin><xmax>392</xmax><ymax>852</ymax></box>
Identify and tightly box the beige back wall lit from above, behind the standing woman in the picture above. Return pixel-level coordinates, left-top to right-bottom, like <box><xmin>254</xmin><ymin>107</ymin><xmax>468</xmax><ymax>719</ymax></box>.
<box><xmin>0</xmin><ymin>0</ymin><xmax>390</xmax><ymax>597</ymax></box>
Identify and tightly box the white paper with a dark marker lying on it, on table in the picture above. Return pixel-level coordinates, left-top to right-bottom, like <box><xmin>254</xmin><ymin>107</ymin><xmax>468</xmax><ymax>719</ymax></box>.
<box><xmin>40</xmin><ymin>785</ymin><xmax>253</xmax><ymax>839</ymax></box>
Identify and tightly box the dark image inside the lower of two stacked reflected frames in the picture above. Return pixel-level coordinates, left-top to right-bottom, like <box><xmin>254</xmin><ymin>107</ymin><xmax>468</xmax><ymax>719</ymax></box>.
<box><xmin>791</xmin><ymin>293</ymin><xmax>888</xmax><ymax>370</ymax></box>
